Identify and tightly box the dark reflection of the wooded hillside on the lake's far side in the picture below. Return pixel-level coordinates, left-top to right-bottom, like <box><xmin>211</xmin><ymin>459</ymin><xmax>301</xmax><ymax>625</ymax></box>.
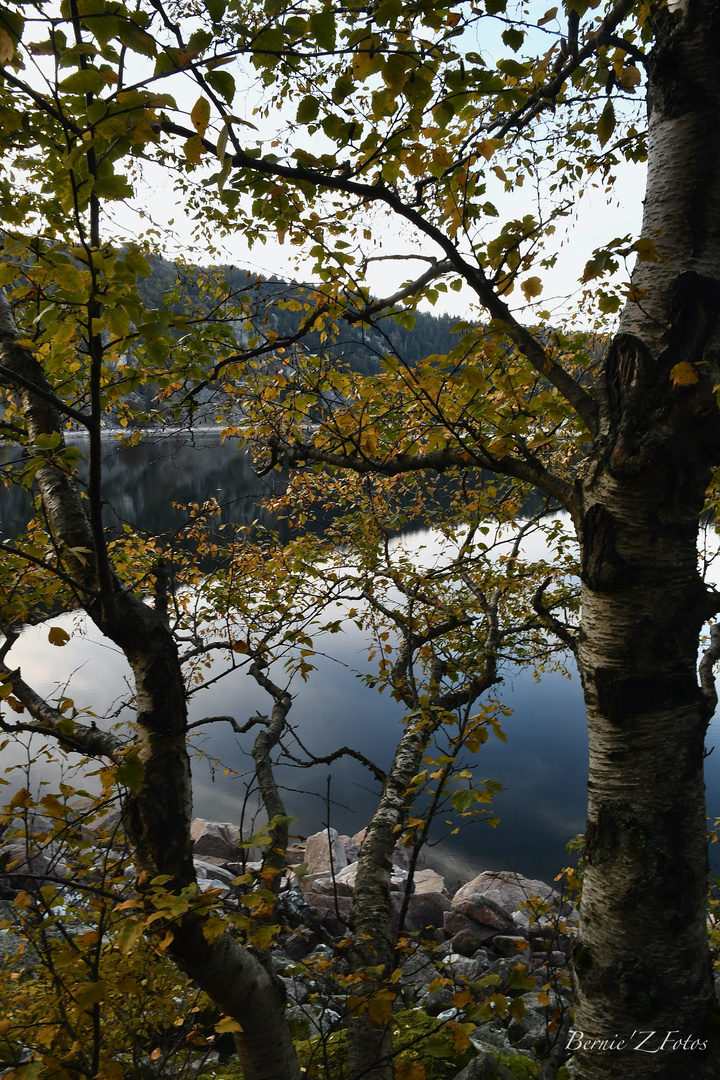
<box><xmin>0</xmin><ymin>433</ymin><xmax>285</xmax><ymax>537</ymax></box>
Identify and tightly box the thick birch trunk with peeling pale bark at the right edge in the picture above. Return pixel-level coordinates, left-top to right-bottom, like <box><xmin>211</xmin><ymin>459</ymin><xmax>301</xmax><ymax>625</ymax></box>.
<box><xmin>570</xmin><ymin>0</ymin><xmax>720</xmax><ymax>1080</ymax></box>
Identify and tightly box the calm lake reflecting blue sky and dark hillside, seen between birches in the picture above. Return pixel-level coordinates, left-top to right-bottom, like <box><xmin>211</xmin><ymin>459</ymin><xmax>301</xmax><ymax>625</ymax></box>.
<box><xmin>0</xmin><ymin>433</ymin><xmax>720</xmax><ymax>885</ymax></box>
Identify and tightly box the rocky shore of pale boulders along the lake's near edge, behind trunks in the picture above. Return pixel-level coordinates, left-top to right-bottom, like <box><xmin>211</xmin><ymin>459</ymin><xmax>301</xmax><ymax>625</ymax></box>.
<box><xmin>0</xmin><ymin>800</ymin><xmax>576</xmax><ymax>1080</ymax></box>
